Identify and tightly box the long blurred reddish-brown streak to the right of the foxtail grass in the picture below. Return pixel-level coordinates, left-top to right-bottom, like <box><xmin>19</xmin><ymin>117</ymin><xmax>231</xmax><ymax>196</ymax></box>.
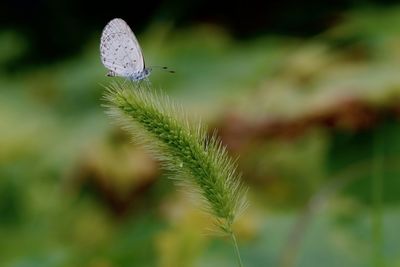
<box><xmin>217</xmin><ymin>97</ymin><xmax>384</xmax><ymax>151</ymax></box>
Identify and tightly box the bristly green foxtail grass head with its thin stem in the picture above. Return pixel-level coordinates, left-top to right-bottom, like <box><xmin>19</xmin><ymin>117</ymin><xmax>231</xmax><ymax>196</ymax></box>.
<box><xmin>104</xmin><ymin>82</ymin><xmax>247</xmax><ymax>266</ymax></box>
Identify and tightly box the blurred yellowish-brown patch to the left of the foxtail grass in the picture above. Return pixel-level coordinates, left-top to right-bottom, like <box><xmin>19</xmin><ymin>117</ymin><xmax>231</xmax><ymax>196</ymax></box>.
<box><xmin>67</xmin><ymin>131</ymin><xmax>159</xmax><ymax>217</ymax></box>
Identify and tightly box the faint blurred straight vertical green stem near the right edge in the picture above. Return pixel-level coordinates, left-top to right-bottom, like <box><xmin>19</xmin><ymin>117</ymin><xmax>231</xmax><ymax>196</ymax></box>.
<box><xmin>371</xmin><ymin>130</ymin><xmax>384</xmax><ymax>267</ymax></box>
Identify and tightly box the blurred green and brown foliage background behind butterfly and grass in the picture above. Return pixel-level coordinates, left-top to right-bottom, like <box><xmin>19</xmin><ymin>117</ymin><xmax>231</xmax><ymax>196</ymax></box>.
<box><xmin>0</xmin><ymin>0</ymin><xmax>400</xmax><ymax>267</ymax></box>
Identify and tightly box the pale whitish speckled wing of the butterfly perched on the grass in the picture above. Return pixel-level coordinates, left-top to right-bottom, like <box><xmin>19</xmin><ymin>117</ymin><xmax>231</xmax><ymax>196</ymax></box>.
<box><xmin>100</xmin><ymin>19</ymin><xmax>144</xmax><ymax>77</ymax></box>
